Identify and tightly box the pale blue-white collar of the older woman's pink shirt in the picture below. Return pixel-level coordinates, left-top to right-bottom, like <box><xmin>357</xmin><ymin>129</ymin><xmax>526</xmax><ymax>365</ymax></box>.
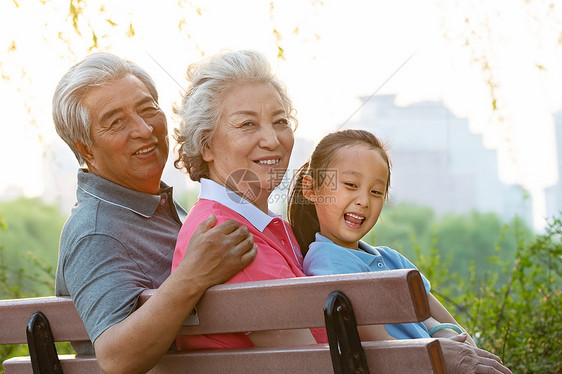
<box><xmin>199</xmin><ymin>178</ymin><xmax>282</xmax><ymax>232</ymax></box>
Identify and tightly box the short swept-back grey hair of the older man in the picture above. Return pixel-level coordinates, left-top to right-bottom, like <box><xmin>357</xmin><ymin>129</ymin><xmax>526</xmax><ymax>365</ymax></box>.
<box><xmin>53</xmin><ymin>52</ymin><xmax>158</xmax><ymax>165</ymax></box>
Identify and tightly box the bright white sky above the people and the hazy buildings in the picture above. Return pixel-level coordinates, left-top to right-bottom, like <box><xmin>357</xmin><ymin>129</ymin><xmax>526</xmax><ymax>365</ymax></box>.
<box><xmin>0</xmin><ymin>0</ymin><xmax>562</xmax><ymax>228</ymax></box>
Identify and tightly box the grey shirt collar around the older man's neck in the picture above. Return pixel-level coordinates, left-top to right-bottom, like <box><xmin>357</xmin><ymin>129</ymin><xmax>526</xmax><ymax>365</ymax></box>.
<box><xmin>78</xmin><ymin>169</ymin><xmax>168</xmax><ymax>218</ymax></box>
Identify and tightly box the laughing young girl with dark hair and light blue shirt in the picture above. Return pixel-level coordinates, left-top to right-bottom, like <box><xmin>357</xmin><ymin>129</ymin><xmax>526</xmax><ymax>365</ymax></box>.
<box><xmin>288</xmin><ymin>130</ymin><xmax>475</xmax><ymax>346</ymax></box>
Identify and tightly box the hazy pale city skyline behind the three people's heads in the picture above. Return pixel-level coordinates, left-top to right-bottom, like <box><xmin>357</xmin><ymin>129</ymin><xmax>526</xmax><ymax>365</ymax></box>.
<box><xmin>5</xmin><ymin>95</ymin><xmax>562</xmax><ymax>231</ymax></box>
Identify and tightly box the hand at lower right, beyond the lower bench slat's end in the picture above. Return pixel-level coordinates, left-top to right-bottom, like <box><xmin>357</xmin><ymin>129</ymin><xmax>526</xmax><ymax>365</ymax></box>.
<box><xmin>439</xmin><ymin>338</ymin><xmax>511</xmax><ymax>374</ymax></box>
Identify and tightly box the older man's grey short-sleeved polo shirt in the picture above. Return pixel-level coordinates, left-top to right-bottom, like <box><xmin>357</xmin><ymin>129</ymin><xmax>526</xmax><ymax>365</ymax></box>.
<box><xmin>55</xmin><ymin>170</ymin><xmax>186</xmax><ymax>350</ymax></box>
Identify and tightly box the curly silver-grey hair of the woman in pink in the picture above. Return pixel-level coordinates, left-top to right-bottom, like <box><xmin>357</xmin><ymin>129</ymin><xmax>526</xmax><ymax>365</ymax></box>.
<box><xmin>174</xmin><ymin>51</ymin><xmax>297</xmax><ymax>181</ymax></box>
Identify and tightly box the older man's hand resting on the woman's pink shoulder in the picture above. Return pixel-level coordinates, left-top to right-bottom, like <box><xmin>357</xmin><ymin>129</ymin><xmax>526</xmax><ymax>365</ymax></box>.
<box><xmin>174</xmin><ymin>214</ymin><xmax>257</xmax><ymax>289</ymax></box>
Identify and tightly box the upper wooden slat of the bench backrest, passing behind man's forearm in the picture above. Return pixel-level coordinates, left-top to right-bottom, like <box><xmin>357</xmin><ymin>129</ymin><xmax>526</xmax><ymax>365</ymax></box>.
<box><xmin>0</xmin><ymin>270</ymin><xmax>429</xmax><ymax>344</ymax></box>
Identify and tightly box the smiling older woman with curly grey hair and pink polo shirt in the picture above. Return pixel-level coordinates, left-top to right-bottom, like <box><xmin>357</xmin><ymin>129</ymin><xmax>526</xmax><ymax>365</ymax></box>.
<box><xmin>172</xmin><ymin>51</ymin><xmax>326</xmax><ymax>349</ymax></box>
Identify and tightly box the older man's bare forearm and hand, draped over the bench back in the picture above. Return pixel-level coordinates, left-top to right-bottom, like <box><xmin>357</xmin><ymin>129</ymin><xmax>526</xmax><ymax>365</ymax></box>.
<box><xmin>94</xmin><ymin>215</ymin><xmax>257</xmax><ymax>373</ymax></box>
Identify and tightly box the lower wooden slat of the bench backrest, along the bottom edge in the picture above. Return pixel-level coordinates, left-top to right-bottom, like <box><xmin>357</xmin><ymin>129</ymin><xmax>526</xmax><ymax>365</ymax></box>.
<box><xmin>4</xmin><ymin>339</ymin><xmax>443</xmax><ymax>374</ymax></box>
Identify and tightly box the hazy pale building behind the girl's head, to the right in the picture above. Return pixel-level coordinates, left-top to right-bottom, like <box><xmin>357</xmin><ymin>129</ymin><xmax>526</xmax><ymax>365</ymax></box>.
<box><xmin>345</xmin><ymin>95</ymin><xmax>532</xmax><ymax>225</ymax></box>
